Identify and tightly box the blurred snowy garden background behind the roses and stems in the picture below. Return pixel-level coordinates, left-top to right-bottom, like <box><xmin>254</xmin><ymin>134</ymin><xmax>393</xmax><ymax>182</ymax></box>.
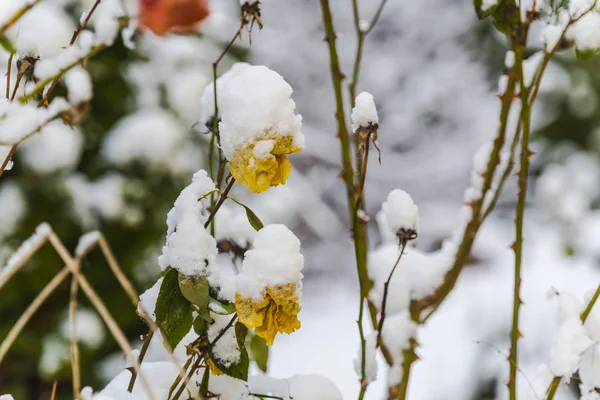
<box><xmin>0</xmin><ymin>0</ymin><xmax>600</xmax><ymax>400</ymax></box>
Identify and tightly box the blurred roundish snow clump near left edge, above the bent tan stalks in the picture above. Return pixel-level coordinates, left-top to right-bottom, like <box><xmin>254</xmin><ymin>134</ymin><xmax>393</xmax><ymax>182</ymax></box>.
<box><xmin>19</xmin><ymin>120</ymin><xmax>83</xmax><ymax>174</ymax></box>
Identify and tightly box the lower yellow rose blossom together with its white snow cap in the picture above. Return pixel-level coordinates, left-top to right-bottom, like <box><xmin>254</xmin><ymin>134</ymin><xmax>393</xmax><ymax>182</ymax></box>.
<box><xmin>235</xmin><ymin>224</ymin><xmax>304</xmax><ymax>345</ymax></box>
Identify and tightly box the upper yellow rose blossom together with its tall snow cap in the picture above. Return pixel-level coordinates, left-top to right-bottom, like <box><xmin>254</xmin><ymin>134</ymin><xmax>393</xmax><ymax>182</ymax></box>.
<box><xmin>217</xmin><ymin>66</ymin><xmax>304</xmax><ymax>193</ymax></box>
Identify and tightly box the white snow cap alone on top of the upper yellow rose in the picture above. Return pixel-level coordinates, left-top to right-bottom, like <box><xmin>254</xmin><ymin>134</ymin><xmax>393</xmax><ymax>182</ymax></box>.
<box><xmin>218</xmin><ymin>66</ymin><xmax>304</xmax><ymax>160</ymax></box>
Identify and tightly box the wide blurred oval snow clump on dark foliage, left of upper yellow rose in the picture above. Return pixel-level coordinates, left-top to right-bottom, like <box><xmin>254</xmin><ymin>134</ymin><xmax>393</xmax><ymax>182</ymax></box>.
<box><xmin>102</xmin><ymin>109</ymin><xmax>185</xmax><ymax>167</ymax></box>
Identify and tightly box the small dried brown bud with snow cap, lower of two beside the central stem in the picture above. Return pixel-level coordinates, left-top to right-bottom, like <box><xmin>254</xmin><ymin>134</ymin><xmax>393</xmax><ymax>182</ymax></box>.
<box><xmin>381</xmin><ymin>189</ymin><xmax>419</xmax><ymax>240</ymax></box>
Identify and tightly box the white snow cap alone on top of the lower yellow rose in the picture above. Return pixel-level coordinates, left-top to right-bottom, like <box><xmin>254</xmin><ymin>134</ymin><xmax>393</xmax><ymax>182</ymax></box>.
<box><xmin>236</xmin><ymin>224</ymin><xmax>304</xmax><ymax>299</ymax></box>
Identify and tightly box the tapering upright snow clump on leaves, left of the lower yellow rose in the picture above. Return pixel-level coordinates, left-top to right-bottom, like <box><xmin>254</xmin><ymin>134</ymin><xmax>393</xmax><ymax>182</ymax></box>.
<box><xmin>158</xmin><ymin>170</ymin><xmax>219</xmax><ymax>286</ymax></box>
